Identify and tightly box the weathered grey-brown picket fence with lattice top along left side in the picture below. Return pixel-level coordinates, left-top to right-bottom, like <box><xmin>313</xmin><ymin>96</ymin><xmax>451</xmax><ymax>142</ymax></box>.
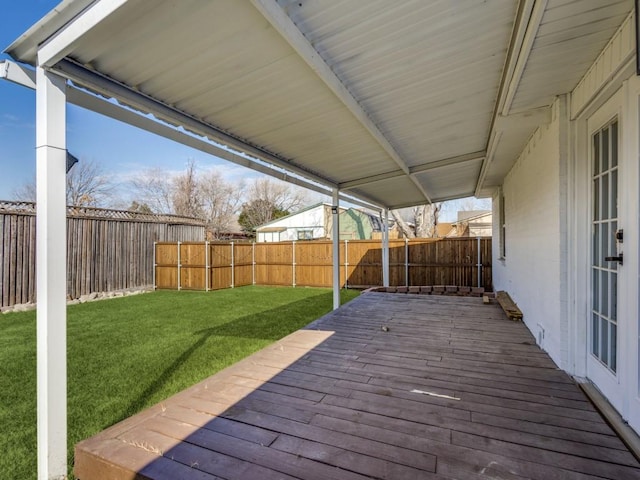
<box><xmin>0</xmin><ymin>202</ymin><xmax>204</xmax><ymax>307</ymax></box>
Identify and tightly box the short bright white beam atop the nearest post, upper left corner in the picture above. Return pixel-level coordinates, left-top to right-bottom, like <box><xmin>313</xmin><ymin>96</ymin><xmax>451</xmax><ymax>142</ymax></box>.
<box><xmin>38</xmin><ymin>0</ymin><xmax>127</xmax><ymax>67</ymax></box>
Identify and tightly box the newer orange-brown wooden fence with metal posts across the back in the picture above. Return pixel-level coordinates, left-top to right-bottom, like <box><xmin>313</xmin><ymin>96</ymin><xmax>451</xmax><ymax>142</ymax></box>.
<box><xmin>154</xmin><ymin>238</ymin><xmax>492</xmax><ymax>290</ymax></box>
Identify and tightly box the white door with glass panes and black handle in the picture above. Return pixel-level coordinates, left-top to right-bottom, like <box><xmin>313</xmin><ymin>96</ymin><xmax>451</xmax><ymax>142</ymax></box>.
<box><xmin>587</xmin><ymin>95</ymin><xmax>625</xmax><ymax>412</ymax></box>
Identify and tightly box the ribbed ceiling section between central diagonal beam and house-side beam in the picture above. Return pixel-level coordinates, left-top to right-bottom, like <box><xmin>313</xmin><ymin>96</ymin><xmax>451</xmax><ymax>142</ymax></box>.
<box><xmin>280</xmin><ymin>0</ymin><xmax>517</xmax><ymax>166</ymax></box>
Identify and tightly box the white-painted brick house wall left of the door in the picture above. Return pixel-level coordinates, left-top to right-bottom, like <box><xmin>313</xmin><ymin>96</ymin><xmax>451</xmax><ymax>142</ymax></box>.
<box><xmin>493</xmin><ymin>97</ymin><xmax>566</xmax><ymax>367</ymax></box>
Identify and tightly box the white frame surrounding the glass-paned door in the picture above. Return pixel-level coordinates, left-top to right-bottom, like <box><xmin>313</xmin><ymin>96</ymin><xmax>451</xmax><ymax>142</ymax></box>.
<box><xmin>567</xmin><ymin>78</ymin><xmax>640</xmax><ymax>433</ymax></box>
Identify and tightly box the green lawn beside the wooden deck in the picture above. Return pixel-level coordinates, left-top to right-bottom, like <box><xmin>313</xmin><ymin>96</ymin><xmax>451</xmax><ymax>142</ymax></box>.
<box><xmin>0</xmin><ymin>287</ymin><xmax>358</xmax><ymax>480</ymax></box>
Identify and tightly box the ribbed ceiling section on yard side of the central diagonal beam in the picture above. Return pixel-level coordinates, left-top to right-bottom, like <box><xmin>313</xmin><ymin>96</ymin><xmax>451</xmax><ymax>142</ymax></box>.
<box><xmin>58</xmin><ymin>0</ymin><xmax>404</xmax><ymax>189</ymax></box>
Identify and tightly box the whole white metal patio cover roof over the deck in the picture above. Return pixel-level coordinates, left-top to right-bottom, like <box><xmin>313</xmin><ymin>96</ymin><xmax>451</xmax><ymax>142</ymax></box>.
<box><xmin>7</xmin><ymin>0</ymin><xmax>633</xmax><ymax>208</ymax></box>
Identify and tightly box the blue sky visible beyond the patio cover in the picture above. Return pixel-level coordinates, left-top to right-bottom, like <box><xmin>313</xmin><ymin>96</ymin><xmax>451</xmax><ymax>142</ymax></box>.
<box><xmin>0</xmin><ymin>0</ymin><xmax>490</xmax><ymax>221</ymax></box>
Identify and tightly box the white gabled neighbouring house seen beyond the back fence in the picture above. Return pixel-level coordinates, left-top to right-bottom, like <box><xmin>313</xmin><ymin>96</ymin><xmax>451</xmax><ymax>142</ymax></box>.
<box><xmin>256</xmin><ymin>203</ymin><xmax>382</xmax><ymax>242</ymax></box>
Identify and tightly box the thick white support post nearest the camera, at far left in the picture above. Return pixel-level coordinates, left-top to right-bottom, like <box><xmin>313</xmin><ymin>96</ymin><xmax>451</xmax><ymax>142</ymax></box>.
<box><xmin>36</xmin><ymin>68</ymin><xmax>67</xmax><ymax>480</ymax></box>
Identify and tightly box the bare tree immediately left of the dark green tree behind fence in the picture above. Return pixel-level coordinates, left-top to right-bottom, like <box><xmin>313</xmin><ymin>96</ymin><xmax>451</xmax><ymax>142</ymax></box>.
<box><xmin>198</xmin><ymin>170</ymin><xmax>243</xmax><ymax>239</ymax></box>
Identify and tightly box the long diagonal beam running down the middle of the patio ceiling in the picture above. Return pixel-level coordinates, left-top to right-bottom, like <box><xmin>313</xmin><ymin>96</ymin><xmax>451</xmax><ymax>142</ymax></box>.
<box><xmin>251</xmin><ymin>0</ymin><xmax>430</xmax><ymax>202</ymax></box>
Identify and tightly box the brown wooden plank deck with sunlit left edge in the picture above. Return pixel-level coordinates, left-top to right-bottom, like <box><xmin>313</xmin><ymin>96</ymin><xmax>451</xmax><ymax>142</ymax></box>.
<box><xmin>75</xmin><ymin>293</ymin><xmax>640</xmax><ymax>480</ymax></box>
